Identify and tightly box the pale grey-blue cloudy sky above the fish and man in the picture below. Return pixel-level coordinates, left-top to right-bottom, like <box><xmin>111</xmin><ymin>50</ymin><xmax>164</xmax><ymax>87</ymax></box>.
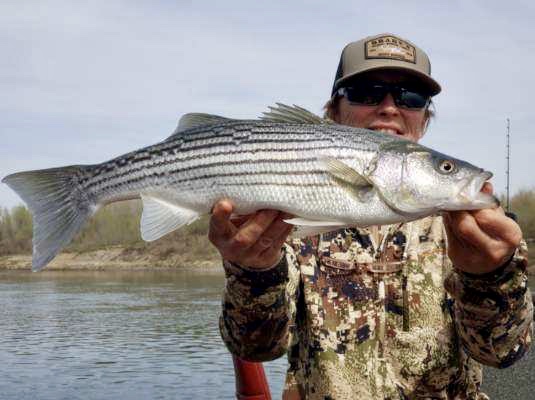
<box><xmin>0</xmin><ymin>0</ymin><xmax>535</xmax><ymax>207</ymax></box>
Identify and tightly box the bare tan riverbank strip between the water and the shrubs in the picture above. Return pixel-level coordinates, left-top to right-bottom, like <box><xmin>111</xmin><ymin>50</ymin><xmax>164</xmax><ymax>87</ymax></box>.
<box><xmin>0</xmin><ymin>246</ymin><xmax>223</xmax><ymax>272</ymax></box>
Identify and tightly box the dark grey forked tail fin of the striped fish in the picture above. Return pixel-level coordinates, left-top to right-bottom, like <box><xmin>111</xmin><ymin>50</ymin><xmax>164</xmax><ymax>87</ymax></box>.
<box><xmin>2</xmin><ymin>165</ymin><xmax>97</xmax><ymax>271</ymax></box>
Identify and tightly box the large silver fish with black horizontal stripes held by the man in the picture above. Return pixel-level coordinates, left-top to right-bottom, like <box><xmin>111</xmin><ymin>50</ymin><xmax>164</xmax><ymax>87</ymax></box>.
<box><xmin>2</xmin><ymin>103</ymin><xmax>497</xmax><ymax>271</ymax></box>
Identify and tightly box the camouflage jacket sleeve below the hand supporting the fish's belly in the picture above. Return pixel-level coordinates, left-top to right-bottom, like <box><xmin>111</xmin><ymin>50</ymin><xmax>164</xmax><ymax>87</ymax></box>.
<box><xmin>219</xmin><ymin>245</ymin><xmax>299</xmax><ymax>361</ymax></box>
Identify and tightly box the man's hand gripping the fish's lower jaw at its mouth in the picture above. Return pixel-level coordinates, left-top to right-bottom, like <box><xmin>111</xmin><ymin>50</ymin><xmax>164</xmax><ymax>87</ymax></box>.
<box><xmin>444</xmin><ymin>182</ymin><xmax>522</xmax><ymax>274</ymax></box>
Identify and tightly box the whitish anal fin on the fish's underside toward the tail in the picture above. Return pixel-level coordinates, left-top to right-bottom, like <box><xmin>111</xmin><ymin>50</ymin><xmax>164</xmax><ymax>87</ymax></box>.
<box><xmin>141</xmin><ymin>195</ymin><xmax>200</xmax><ymax>242</ymax></box>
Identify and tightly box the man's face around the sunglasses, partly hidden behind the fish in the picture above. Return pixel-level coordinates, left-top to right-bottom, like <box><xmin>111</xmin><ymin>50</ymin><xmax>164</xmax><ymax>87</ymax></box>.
<box><xmin>335</xmin><ymin>71</ymin><xmax>427</xmax><ymax>142</ymax></box>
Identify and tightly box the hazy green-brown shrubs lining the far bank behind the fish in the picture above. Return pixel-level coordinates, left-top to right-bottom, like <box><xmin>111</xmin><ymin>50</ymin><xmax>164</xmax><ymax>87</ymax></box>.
<box><xmin>0</xmin><ymin>190</ymin><xmax>535</xmax><ymax>261</ymax></box>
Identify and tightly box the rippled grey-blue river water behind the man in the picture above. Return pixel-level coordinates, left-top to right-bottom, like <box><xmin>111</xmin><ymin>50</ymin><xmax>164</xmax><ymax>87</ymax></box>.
<box><xmin>0</xmin><ymin>271</ymin><xmax>535</xmax><ymax>400</ymax></box>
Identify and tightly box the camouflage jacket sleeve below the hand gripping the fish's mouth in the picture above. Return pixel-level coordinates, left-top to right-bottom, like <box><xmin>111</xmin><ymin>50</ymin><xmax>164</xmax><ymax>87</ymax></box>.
<box><xmin>445</xmin><ymin>241</ymin><xmax>533</xmax><ymax>368</ymax></box>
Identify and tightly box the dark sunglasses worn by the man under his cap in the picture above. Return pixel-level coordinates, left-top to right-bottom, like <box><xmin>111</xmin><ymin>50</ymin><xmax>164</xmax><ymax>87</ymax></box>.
<box><xmin>336</xmin><ymin>82</ymin><xmax>431</xmax><ymax>110</ymax></box>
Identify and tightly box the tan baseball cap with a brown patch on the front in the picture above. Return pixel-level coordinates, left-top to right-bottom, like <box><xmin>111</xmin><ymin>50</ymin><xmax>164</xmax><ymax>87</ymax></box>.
<box><xmin>332</xmin><ymin>33</ymin><xmax>441</xmax><ymax>96</ymax></box>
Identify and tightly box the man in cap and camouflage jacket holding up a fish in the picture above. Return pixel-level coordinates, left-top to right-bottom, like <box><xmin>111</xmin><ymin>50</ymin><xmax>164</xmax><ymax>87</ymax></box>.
<box><xmin>209</xmin><ymin>34</ymin><xmax>533</xmax><ymax>399</ymax></box>
